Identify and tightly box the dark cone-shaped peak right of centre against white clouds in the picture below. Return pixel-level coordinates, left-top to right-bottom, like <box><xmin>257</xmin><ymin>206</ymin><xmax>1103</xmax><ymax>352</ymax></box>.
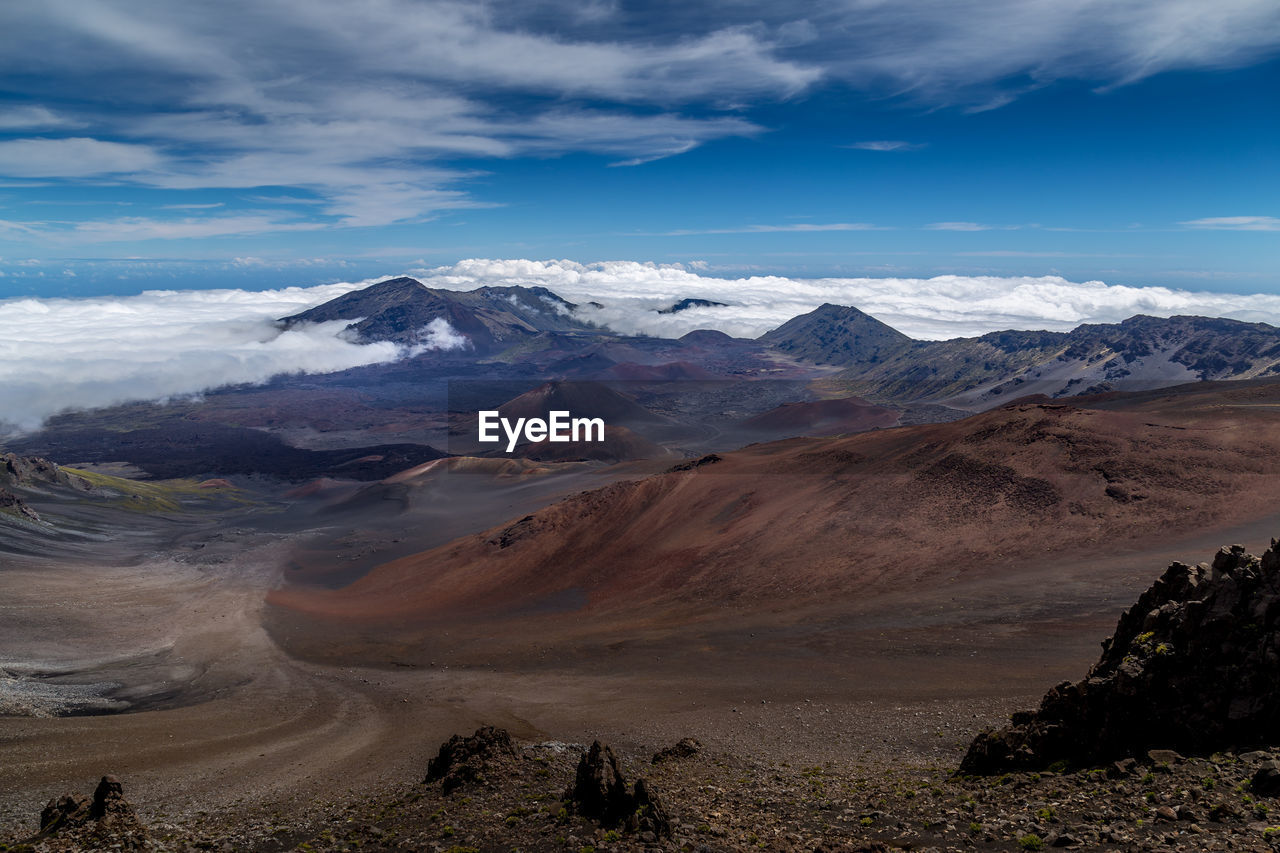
<box><xmin>758</xmin><ymin>304</ymin><xmax>913</xmax><ymax>365</ymax></box>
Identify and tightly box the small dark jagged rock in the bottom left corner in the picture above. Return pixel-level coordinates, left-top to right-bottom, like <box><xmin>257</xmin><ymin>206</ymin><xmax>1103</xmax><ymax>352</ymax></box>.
<box><xmin>32</xmin><ymin>776</ymin><xmax>150</xmax><ymax>850</ymax></box>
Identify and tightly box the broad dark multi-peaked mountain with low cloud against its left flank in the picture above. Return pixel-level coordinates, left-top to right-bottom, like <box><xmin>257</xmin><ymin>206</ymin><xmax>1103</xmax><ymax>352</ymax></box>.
<box><xmin>280</xmin><ymin>278</ymin><xmax>591</xmax><ymax>355</ymax></box>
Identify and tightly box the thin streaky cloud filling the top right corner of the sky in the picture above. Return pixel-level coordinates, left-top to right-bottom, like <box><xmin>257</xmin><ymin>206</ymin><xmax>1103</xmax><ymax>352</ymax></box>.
<box><xmin>818</xmin><ymin>0</ymin><xmax>1280</xmax><ymax>110</ymax></box>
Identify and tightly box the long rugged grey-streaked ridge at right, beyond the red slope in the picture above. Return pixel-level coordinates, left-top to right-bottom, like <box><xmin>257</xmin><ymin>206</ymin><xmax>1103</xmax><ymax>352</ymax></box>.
<box><xmin>839</xmin><ymin>315</ymin><xmax>1280</xmax><ymax>410</ymax></box>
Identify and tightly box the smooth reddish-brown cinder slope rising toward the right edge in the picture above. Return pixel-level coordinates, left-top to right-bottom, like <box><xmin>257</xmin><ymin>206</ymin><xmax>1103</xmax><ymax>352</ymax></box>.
<box><xmin>273</xmin><ymin>382</ymin><xmax>1280</xmax><ymax>630</ymax></box>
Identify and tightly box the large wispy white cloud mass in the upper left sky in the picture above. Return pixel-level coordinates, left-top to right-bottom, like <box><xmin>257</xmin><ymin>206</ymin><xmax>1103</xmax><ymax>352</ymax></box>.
<box><xmin>0</xmin><ymin>0</ymin><xmax>803</xmax><ymax>229</ymax></box>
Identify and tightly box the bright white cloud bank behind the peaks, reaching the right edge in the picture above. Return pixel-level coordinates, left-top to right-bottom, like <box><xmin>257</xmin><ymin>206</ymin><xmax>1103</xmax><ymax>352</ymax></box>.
<box><xmin>415</xmin><ymin>259</ymin><xmax>1280</xmax><ymax>339</ymax></box>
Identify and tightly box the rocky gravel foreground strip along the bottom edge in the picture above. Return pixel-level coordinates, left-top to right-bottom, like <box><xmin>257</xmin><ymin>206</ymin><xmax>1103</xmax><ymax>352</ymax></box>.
<box><xmin>12</xmin><ymin>722</ymin><xmax>1280</xmax><ymax>853</ymax></box>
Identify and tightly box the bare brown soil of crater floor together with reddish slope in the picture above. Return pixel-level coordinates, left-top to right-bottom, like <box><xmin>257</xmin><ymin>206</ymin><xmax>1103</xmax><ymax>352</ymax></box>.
<box><xmin>0</xmin><ymin>384</ymin><xmax>1280</xmax><ymax>850</ymax></box>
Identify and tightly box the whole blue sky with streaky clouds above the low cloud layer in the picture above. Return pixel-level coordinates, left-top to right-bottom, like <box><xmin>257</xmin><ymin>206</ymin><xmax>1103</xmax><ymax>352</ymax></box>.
<box><xmin>0</xmin><ymin>0</ymin><xmax>1280</xmax><ymax>296</ymax></box>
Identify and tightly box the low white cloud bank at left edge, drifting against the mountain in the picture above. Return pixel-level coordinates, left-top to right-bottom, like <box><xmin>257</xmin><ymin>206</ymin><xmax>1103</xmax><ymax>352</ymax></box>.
<box><xmin>0</xmin><ymin>282</ymin><xmax>407</xmax><ymax>432</ymax></box>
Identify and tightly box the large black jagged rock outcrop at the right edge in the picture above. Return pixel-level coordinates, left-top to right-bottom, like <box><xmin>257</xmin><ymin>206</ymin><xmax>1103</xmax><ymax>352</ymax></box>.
<box><xmin>960</xmin><ymin>540</ymin><xmax>1280</xmax><ymax>774</ymax></box>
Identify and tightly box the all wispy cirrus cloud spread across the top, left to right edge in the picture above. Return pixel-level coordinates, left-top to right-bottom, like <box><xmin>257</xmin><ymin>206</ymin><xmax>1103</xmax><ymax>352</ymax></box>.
<box><xmin>0</xmin><ymin>0</ymin><xmax>1280</xmax><ymax>238</ymax></box>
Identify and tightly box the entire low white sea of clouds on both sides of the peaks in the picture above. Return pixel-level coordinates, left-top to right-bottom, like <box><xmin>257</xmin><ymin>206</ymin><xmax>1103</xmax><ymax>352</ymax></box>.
<box><xmin>0</xmin><ymin>260</ymin><xmax>1280</xmax><ymax>434</ymax></box>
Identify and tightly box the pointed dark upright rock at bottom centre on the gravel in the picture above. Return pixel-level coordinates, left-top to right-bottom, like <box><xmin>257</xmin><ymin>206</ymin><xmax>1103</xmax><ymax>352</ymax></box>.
<box><xmin>564</xmin><ymin>740</ymin><xmax>671</xmax><ymax>838</ymax></box>
